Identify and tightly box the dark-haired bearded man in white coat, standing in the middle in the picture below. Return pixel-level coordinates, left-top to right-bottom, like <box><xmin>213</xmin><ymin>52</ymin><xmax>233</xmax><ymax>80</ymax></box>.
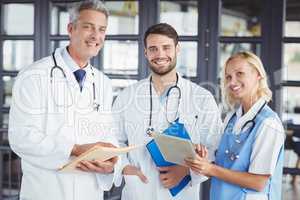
<box><xmin>113</xmin><ymin>23</ymin><xmax>221</xmax><ymax>200</ymax></box>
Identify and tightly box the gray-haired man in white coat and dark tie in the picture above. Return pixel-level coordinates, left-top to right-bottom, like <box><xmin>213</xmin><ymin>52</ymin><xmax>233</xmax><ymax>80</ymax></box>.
<box><xmin>9</xmin><ymin>0</ymin><xmax>117</xmax><ymax>200</ymax></box>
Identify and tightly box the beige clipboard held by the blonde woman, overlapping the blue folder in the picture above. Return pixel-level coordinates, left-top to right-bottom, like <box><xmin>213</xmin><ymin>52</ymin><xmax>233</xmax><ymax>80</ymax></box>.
<box><xmin>154</xmin><ymin>134</ymin><xmax>196</xmax><ymax>166</ymax></box>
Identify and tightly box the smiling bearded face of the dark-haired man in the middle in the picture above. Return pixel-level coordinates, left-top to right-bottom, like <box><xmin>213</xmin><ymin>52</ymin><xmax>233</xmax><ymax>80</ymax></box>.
<box><xmin>145</xmin><ymin>34</ymin><xmax>179</xmax><ymax>75</ymax></box>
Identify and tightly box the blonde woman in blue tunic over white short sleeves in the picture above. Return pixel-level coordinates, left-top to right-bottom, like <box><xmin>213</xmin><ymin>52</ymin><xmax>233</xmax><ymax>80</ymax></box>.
<box><xmin>187</xmin><ymin>52</ymin><xmax>285</xmax><ymax>200</ymax></box>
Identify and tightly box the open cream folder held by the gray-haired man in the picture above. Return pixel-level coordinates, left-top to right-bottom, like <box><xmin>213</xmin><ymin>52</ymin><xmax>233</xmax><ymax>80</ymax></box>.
<box><xmin>59</xmin><ymin>145</ymin><xmax>142</xmax><ymax>172</ymax></box>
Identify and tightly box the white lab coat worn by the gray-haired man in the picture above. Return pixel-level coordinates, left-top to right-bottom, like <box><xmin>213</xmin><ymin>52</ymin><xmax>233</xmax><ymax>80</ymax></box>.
<box><xmin>9</xmin><ymin>49</ymin><xmax>117</xmax><ymax>200</ymax></box>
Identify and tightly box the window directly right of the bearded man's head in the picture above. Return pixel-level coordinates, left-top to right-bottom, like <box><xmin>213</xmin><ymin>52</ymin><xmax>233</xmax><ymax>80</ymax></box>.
<box><xmin>159</xmin><ymin>1</ymin><xmax>198</xmax><ymax>77</ymax></box>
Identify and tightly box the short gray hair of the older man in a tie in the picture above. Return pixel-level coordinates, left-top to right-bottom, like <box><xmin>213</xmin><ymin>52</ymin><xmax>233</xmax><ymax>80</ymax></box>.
<box><xmin>69</xmin><ymin>0</ymin><xmax>109</xmax><ymax>23</ymax></box>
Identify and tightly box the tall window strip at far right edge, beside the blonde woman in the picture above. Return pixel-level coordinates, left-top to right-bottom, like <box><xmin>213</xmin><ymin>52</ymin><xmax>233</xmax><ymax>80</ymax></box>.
<box><xmin>282</xmin><ymin>0</ymin><xmax>300</xmax><ymax>124</ymax></box>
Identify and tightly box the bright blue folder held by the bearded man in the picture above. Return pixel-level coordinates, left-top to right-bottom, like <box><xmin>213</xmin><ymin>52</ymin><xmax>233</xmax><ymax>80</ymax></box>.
<box><xmin>146</xmin><ymin>119</ymin><xmax>191</xmax><ymax>197</ymax></box>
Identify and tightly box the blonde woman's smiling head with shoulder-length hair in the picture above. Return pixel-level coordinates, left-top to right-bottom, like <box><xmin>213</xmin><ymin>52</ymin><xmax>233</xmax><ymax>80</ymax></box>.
<box><xmin>222</xmin><ymin>52</ymin><xmax>272</xmax><ymax>112</ymax></box>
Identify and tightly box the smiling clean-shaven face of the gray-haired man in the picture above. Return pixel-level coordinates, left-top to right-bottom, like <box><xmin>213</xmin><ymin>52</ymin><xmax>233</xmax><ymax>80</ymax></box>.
<box><xmin>68</xmin><ymin>10</ymin><xmax>107</xmax><ymax>60</ymax></box>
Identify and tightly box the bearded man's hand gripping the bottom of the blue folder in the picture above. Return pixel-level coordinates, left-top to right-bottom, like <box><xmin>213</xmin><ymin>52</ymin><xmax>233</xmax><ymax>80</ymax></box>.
<box><xmin>158</xmin><ymin>165</ymin><xmax>189</xmax><ymax>189</ymax></box>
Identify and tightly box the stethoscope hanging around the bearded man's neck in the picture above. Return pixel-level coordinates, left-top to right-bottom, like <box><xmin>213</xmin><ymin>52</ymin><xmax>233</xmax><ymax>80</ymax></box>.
<box><xmin>146</xmin><ymin>74</ymin><xmax>181</xmax><ymax>136</ymax></box>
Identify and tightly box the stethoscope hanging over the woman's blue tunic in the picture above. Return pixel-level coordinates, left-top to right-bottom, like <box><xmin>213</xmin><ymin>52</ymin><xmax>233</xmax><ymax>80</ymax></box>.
<box><xmin>225</xmin><ymin>102</ymin><xmax>267</xmax><ymax>161</ymax></box>
